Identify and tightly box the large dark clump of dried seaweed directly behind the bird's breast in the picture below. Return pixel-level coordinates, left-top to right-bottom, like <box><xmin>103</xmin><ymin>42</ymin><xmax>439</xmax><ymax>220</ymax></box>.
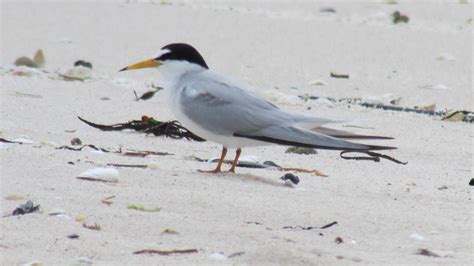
<box><xmin>78</xmin><ymin>116</ymin><xmax>205</xmax><ymax>141</ymax></box>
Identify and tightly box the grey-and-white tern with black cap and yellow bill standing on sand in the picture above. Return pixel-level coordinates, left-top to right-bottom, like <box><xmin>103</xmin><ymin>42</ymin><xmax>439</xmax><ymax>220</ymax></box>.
<box><xmin>120</xmin><ymin>43</ymin><xmax>396</xmax><ymax>173</ymax></box>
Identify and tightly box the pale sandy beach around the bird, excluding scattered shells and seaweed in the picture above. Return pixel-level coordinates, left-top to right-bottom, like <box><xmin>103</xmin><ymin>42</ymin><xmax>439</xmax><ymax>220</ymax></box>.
<box><xmin>0</xmin><ymin>0</ymin><xmax>474</xmax><ymax>265</ymax></box>
